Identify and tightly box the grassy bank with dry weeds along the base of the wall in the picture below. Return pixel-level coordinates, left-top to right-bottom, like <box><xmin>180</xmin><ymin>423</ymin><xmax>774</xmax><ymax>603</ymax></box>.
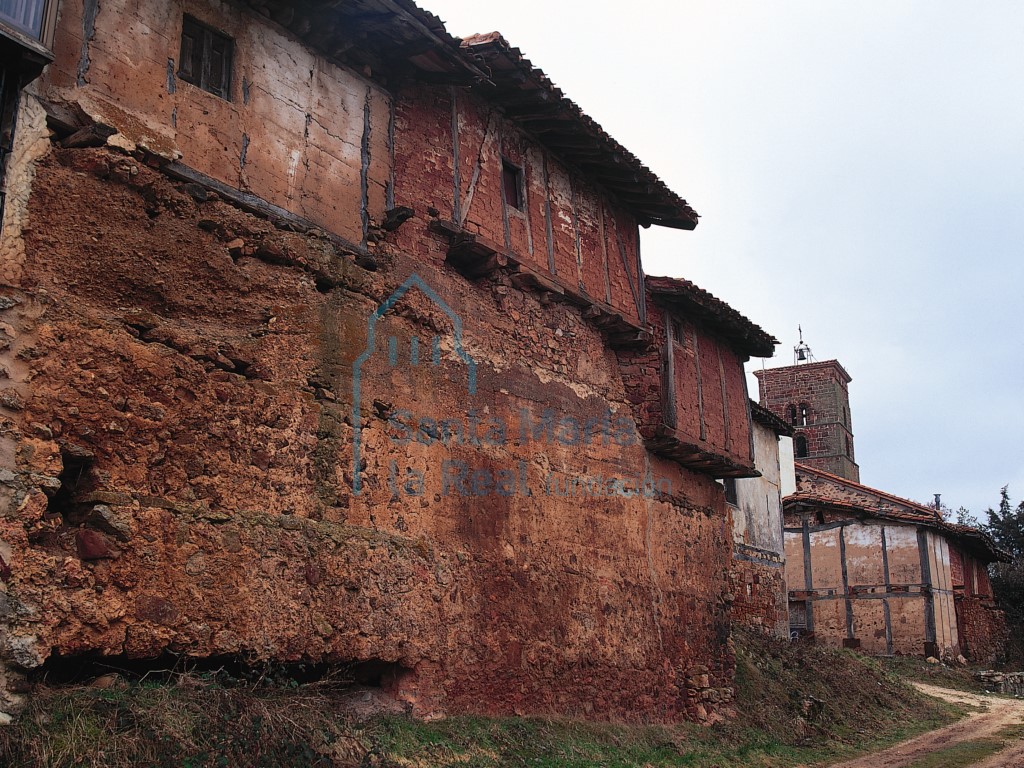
<box><xmin>0</xmin><ymin>636</ymin><xmax>963</xmax><ymax>768</ymax></box>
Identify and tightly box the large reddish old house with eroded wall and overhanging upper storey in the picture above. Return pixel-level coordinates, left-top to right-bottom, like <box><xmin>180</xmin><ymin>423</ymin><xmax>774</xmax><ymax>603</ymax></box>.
<box><xmin>0</xmin><ymin>0</ymin><xmax>774</xmax><ymax>722</ymax></box>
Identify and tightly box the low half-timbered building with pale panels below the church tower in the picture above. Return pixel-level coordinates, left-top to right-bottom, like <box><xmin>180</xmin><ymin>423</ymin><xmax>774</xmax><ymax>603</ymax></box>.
<box><xmin>784</xmin><ymin>462</ymin><xmax>1007</xmax><ymax>662</ymax></box>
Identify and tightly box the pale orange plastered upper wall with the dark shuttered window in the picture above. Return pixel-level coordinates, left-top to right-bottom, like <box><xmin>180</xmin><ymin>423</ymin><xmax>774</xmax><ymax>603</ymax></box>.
<box><xmin>36</xmin><ymin>0</ymin><xmax>392</xmax><ymax>244</ymax></box>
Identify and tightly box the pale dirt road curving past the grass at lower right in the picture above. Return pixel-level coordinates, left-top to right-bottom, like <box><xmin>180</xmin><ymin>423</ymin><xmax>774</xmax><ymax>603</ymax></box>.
<box><xmin>831</xmin><ymin>683</ymin><xmax>1024</xmax><ymax>768</ymax></box>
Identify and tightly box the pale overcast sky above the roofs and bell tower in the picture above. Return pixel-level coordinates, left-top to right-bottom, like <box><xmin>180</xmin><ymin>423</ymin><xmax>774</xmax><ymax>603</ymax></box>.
<box><xmin>420</xmin><ymin>0</ymin><xmax>1024</xmax><ymax>513</ymax></box>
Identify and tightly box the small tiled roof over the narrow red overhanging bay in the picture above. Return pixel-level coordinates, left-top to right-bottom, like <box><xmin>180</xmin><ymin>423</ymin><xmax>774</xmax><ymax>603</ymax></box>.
<box><xmin>644</xmin><ymin>276</ymin><xmax>778</xmax><ymax>357</ymax></box>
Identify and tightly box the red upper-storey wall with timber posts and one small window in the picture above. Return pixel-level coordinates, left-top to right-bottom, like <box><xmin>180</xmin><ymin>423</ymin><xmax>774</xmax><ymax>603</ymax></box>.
<box><xmin>393</xmin><ymin>87</ymin><xmax>642</xmax><ymax>324</ymax></box>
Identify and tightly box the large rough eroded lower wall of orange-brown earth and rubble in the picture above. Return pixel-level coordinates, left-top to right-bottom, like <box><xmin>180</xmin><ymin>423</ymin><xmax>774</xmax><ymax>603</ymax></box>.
<box><xmin>0</xmin><ymin>147</ymin><xmax>733</xmax><ymax>722</ymax></box>
